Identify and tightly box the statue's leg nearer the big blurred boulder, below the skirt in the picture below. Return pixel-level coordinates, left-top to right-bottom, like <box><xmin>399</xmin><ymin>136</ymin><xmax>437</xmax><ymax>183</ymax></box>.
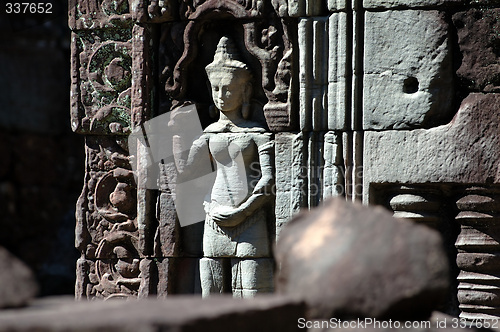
<box><xmin>231</xmin><ymin>258</ymin><xmax>274</xmax><ymax>298</ymax></box>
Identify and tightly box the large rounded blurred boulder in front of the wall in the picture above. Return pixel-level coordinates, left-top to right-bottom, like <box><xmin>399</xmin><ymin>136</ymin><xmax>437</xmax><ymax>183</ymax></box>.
<box><xmin>276</xmin><ymin>198</ymin><xmax>448</xmax><ymax>319</ymax></box>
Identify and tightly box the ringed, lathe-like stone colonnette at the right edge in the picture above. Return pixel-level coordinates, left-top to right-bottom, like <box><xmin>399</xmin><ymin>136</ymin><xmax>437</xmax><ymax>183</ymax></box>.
<box><xmin>455</xmin><ymin>187</ymin><xmax>500</xmax><ymax>319</ymax></box>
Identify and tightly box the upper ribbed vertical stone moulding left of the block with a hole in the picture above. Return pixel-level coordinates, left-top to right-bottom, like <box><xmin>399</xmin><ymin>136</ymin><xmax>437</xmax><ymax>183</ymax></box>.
<box><xmin>298</xmin><ymin>13</ymin><xmax>347</xmax><ymax>131</ymax></box>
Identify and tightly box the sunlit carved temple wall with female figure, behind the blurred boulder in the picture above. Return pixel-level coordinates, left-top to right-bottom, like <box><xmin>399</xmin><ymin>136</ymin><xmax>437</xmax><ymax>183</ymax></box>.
<box><xmin>70</xmin><ymin>0</ymin><xmax>500</xmax><ymax>318</ymax></box>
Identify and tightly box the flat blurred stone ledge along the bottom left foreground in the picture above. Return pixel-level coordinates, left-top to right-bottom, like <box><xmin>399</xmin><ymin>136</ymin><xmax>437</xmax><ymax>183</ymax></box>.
<box><xmin>0</xmin><ymin>296</ymin><xmax>304</xmax><ymax>332</ymax></box>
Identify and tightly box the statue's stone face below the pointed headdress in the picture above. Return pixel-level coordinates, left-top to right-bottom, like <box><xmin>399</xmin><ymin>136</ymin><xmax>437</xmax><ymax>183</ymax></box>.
<box><xmin>209</xmin><ymin>72</ymin><xmax>247</xmax><ymax>112</ymax></box>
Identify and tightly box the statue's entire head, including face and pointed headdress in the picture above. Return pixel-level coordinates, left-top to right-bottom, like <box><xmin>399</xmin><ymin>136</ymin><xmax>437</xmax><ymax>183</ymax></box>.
<box><xmin>205</xmin><ymin>37</ymin><xmax>252</xmax><ymax>112</ymax></box>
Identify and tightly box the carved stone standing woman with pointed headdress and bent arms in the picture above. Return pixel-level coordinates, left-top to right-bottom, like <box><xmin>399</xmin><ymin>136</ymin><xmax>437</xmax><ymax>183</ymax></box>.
<box><xmin>172</xmin><ymin>37</ymin><xmax>274</xmax><ymax>297</ymax></box>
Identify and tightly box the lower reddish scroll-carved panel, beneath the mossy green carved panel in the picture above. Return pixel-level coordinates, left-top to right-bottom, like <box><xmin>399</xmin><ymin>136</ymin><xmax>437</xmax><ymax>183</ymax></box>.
<box><xmin>75</xmin><ymin>136</ymin><xmax>140</xmax><ymax>298</ymax></box>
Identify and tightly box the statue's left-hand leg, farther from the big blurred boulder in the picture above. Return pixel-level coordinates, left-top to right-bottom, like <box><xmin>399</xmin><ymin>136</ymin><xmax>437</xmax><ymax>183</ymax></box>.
<box><xmin>200</xmin><ymin>257</ymin><xmax>228</xmax><ymax>297</ymax></box>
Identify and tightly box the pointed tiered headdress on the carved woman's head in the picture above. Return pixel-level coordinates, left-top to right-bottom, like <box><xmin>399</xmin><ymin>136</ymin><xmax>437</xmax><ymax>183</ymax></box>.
<box><xmin>205</xmin><ymin>36</ymin><xmax>252</xmax><ymax>78</ymax></box>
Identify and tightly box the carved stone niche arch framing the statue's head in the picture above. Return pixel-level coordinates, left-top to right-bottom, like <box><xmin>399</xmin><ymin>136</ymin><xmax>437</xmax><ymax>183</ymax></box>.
<box><xmin>161</xmin><ymin>0</ymin><xmax>295</xmax><ymax>131</ymax></box>
